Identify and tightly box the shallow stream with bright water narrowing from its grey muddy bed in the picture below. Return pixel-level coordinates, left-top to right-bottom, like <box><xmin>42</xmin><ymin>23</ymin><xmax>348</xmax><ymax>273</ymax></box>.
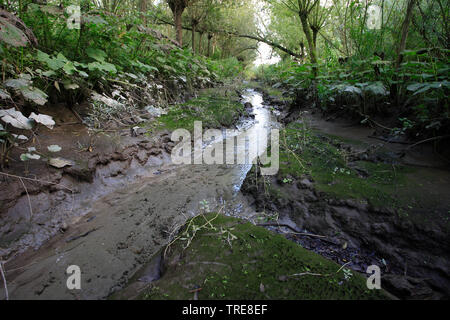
<box><xmin>1</xmin><ymin>89</ymin><xmax>276</xmax><ymax>299</ymax></box>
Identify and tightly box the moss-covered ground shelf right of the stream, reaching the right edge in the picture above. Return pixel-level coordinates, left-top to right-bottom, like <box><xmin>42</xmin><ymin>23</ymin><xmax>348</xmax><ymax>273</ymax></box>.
<box><xmin>269</xmin><ymin>122</ymin><xmax>450</xmax><ymax>229</ymax></box>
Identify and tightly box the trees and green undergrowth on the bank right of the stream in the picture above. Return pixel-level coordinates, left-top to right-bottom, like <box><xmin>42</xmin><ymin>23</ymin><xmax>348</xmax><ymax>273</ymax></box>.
<box><xmin>256</xmin><ymin>0</ymin><xmax>450</xmax><ymax>140</ymax></box>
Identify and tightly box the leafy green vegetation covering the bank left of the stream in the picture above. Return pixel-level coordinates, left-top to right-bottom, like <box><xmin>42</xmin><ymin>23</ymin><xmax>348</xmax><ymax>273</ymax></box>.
<box><xmin>0</xmin><ymin>0</ymin><xmax>256</xmax><ymax>168</ymax></box>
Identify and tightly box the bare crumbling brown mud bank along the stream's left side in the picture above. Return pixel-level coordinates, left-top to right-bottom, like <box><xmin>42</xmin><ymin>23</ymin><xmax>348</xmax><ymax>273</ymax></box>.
<box><xmin>0</xmin><ymin>125</ymin><xmax>174</xmax><ymax>260</ymax></box>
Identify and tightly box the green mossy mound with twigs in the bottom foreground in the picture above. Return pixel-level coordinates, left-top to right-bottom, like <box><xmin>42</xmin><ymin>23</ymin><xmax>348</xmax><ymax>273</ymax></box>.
<box><xmin>139</xmin><ymin>214</ymin><xmax>386</xmax><ymax>299</ymax></box>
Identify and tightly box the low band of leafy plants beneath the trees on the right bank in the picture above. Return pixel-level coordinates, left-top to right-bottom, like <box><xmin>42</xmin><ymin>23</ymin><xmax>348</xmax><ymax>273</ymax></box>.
<box><xmin>258</xmin><ymin>48</ymin><xmax>450</xmax><ymax>138</ymax></box>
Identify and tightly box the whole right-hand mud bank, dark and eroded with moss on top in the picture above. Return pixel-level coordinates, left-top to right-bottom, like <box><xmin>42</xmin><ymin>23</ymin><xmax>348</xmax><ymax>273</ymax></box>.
<box><xmin>242</xmin><ymin>108</ymin><xmax>450</xmax><ymax>299</ymax></box>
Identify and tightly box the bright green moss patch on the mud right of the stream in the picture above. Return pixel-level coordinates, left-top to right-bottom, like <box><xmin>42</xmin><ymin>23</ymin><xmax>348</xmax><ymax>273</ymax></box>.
<box><xmin>279</xmin><ymin>123</ymin><xmax>412</xmax><ymax>206</ymax></box>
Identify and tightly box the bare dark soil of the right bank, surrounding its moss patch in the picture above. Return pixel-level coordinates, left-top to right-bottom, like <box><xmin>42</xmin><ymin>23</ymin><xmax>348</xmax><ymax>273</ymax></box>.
<box><xmin>242</xmin><ymin>89</ymin><xmax>450</xmax><ymax>299</ymax></box>
